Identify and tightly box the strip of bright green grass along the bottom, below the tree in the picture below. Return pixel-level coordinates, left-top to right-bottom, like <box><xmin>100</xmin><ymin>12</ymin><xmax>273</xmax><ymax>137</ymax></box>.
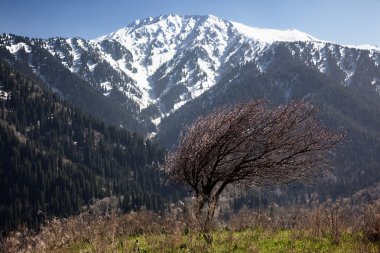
<box><xmin>62</xmin><ymin>229</ymin><xmax>379</xmax><ymax>253</ymax></box>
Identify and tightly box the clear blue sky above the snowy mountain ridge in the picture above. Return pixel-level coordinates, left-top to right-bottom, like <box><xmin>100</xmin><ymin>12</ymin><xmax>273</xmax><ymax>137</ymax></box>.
<box><xmin>0</xmin><ymin>0</ymin><xmax>380</xmax><ymax>46</ymax></box>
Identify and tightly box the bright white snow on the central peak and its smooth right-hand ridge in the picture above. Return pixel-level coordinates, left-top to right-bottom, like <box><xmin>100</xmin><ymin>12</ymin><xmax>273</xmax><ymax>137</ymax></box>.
<box><xmin>91</xmin><ymin>14</ymin><xmax>324</xmax><ymax>113</ymax></box>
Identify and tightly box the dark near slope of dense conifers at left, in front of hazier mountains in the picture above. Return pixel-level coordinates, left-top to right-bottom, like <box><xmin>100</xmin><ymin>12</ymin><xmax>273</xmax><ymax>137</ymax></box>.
<box><xmin>0</xmin><ymin>61</ymin><xmax>174</xmax><ymax>234</ymax></box>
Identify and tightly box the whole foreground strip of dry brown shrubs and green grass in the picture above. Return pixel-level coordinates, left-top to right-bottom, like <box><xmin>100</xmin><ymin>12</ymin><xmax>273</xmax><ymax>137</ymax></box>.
<box><xmin>0</xmin><ymin>200</ymin><xmax>380</xmax><ymax>252</ymax></box>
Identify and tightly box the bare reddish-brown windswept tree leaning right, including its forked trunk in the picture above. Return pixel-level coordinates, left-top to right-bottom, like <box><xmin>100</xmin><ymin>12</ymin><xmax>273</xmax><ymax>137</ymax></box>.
<box><xmin>162</xmin><ymin>100</ymin><xmax>344</xmax><ymax>230</ymax></box>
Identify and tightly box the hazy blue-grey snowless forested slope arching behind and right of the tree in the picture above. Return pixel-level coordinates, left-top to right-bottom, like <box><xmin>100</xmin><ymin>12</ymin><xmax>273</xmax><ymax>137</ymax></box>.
<box><xmin>156</xmin><ymin>55</ymin><xmax>380</xmax><ymax>203</ymax></box>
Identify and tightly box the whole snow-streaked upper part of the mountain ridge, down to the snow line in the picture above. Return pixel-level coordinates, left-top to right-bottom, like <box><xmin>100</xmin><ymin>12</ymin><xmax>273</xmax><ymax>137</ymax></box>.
<box><xmin>2</xmin><ymin>14</ymin><xmax>380</xmax><ymax>128</ymax></box>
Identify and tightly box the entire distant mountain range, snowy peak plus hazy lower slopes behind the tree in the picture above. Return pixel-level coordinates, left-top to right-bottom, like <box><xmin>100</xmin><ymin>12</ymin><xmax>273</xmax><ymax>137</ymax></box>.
<box><xmin>0</xmin><ymin>14</ymin><xmax>380</xmax><ymax>231</ymax></box>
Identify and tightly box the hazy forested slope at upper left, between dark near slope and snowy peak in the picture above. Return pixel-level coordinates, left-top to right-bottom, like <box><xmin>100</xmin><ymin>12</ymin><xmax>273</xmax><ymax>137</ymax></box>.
<box><xmin>0</xmin><ymin>35</ymin><xmax>151</xmax><ymax>132</ymax></box>
